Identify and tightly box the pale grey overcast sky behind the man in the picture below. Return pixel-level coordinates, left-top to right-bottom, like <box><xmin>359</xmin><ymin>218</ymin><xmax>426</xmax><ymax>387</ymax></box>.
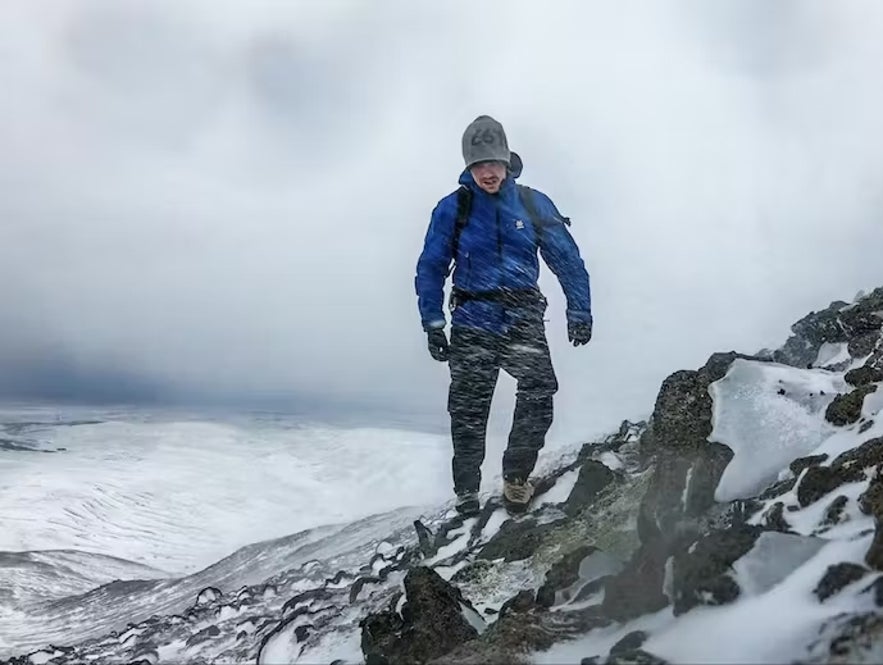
<box><xmin>0</xmin><ymin>0</ymin><xmax>883</xmax><ymax>444</ymax></box>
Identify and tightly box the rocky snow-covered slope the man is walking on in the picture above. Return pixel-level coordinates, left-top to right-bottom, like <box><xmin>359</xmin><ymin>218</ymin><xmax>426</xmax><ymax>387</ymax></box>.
<box><xmin>8</xmin><ymin>290</ymin><xmax>883</xmax><ymax>664</ymax></box>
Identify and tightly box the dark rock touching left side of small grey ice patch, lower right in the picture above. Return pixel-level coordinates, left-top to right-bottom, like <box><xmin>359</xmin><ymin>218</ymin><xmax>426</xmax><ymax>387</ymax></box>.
<box><xmin>673</xmin><ymin>524</ymin><xmax>763</xmax><ymax>616</ymax></box>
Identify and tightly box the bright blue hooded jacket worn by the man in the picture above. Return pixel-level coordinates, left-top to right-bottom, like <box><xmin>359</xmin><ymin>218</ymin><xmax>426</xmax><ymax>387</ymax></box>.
<box><xmin>414</xmin><ymin>170</ymin><xmax>592</xmax><ymax>333</ymax></box>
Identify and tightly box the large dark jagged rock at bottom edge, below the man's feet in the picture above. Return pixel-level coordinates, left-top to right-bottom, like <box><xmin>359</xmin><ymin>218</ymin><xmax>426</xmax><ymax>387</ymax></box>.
<box><xmin>359</xmin><ymin>566</ymin><xmax>478</xmax><ymax>665</ymax></box>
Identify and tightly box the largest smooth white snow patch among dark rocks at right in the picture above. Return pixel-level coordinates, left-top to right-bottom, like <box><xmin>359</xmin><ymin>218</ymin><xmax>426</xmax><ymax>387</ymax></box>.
<box><xmin>709</xmin><ymin>358</ymin><xmax>847</xmax><ymax>501</ymax></box>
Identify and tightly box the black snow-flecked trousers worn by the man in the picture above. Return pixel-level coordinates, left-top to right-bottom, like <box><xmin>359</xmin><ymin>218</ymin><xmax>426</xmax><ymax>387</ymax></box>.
<box><xmin>448</xmin><ymin>311</ymin><xmax>558</xmax><ymax>494</ymax></box>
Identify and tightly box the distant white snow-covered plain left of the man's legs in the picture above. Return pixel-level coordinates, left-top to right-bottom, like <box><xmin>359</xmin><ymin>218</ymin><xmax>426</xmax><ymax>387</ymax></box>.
<box><xmin>0</xmin><ymin>414</ymin><xmax>456</xmax><ymax>573</ymax></box>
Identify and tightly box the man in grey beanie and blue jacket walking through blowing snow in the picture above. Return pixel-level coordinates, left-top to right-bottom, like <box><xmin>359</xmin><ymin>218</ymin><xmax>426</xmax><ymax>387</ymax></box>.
<box><xmin>415</xmin><ymin>115</ymin><xmax>592</xmax><ymax>516</ymax></box>
